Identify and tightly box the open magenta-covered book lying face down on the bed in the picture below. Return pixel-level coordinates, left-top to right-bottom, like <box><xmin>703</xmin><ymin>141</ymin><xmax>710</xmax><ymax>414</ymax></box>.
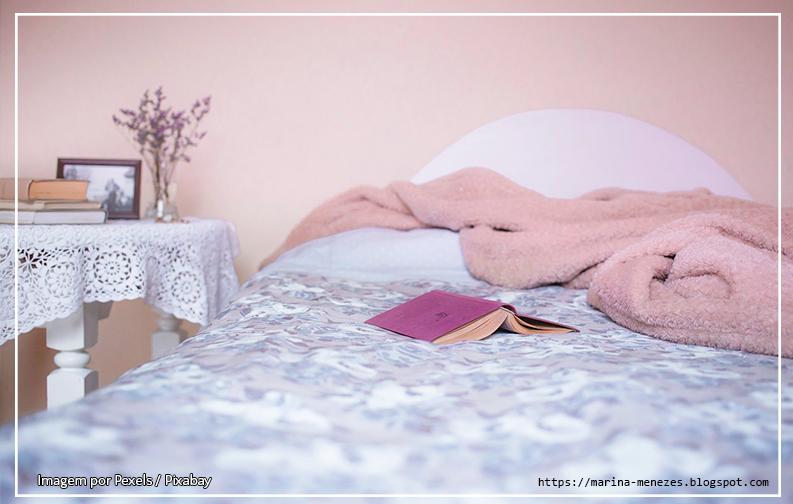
<box><xmin>366</xmin><ymin>290</ymin><xmax>578</xmax><ymax>345</ymax></box>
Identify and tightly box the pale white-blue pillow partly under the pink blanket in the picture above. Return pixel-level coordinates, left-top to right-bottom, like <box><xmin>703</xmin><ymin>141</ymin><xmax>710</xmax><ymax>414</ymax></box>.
<box><xmin>262</xmin><ymin>228</ymin><xmax>476</xmax><ymax>283</ymax></box>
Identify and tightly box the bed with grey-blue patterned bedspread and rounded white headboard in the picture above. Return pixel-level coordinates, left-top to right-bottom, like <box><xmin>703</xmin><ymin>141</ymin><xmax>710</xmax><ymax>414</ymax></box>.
<box><xmin>0</xmin><ymin>111</ymin><xmax>793</xmax><ymax>502</ymax></box>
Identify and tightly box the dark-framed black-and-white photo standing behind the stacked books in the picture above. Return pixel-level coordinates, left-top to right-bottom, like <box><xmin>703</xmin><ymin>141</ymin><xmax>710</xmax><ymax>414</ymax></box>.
<box><xmin>56</xmin><ymin>158</ymin><xmax>141</xmax><ymax>219</ymax></box>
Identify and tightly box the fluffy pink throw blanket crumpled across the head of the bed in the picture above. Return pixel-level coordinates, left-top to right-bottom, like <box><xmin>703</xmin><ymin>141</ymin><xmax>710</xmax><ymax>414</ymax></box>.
<box><xmin>263</xmin><ymin>168</ymin><xmax>793</xmax><ymax>357</ymax></box>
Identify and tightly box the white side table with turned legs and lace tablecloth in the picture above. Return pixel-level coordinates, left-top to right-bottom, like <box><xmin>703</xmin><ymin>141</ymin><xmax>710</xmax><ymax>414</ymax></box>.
<box><xmin>0</xmin><ymin>218</ymin><xmax>239</xmax><ymax>409</ymax></box>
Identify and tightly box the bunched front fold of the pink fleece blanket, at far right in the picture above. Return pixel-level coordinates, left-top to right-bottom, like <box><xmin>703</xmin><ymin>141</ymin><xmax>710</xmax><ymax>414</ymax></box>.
<box><xmin>587</xmin><ymin>214</ymin><xmax>793</xmax><ymax>357</ymax></box>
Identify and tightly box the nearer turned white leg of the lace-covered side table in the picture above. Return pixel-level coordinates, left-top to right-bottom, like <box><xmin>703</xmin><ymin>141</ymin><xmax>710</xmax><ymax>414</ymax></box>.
<box><xmin>45</xmin><ymin>303</ymin><xmax>112</xmax><ymax>409</ymax></box>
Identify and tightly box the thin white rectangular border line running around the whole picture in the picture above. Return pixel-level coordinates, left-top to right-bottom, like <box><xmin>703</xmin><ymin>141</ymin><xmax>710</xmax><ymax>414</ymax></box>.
<box><xmin>14</xmin><ymin>12</ymin><xmax>782</xmax><ymax>499</ymax></box>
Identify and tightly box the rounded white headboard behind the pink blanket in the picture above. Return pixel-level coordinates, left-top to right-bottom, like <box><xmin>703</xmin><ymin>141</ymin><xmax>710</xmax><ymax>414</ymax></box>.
<box><xmin>412</xmin><ymin>109</ymin><xmax>752</xmax><ymax>199</ymax></box>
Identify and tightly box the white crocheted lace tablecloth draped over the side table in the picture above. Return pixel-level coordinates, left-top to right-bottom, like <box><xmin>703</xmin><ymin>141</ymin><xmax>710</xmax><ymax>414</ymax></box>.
<box><xmin>0</xmin><ymin>219</ymin><xmax>239</xmax><ymax>344</ymax></box>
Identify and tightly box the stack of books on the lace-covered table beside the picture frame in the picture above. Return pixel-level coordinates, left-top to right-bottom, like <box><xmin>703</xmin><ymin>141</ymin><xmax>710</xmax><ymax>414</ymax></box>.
<box><xmin>0</xmin><ymin>178</ymin><xmax>107</xmax><ymax>224</ymax></box>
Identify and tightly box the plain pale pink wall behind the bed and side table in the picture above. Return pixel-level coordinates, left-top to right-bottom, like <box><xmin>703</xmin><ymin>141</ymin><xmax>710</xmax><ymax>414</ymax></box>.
<box><xmin>0</xmin><ymin>0</ymin><xmax>793</xmax><ymax>418</ymax></box>
